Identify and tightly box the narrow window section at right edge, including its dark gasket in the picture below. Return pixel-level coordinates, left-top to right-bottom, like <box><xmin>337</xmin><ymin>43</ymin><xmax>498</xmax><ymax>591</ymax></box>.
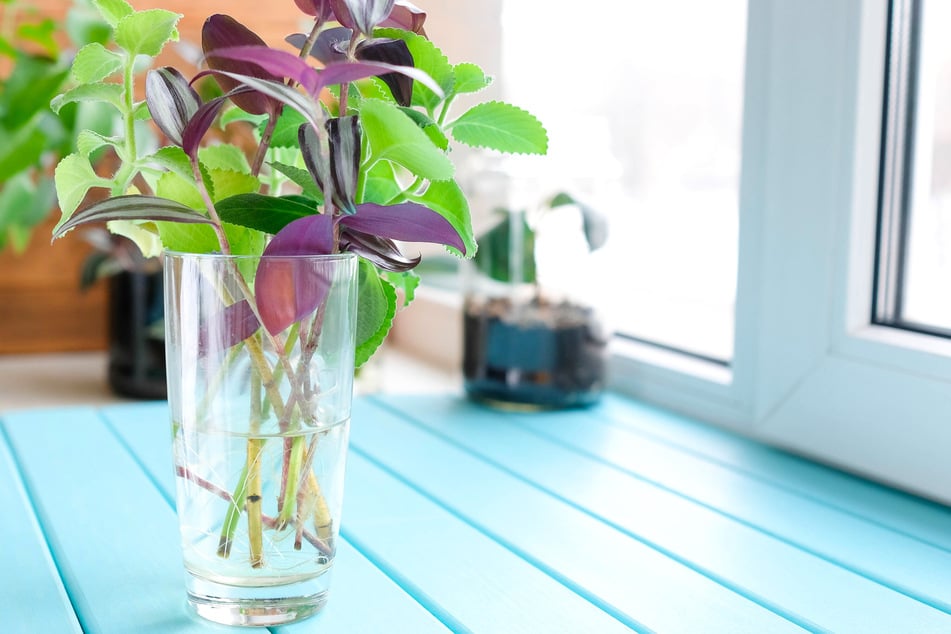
<box><xmin>876</xmin><ymin>0</ymin><xmax>951</xmax><ymax>334</ymax></box>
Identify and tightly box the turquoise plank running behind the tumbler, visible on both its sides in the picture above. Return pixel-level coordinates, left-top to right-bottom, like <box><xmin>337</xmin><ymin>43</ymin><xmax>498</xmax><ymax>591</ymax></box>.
<box><xmin>102</xmin><ymin>403</ymin><xmax>448</xmax><ymax>634</ymax></box>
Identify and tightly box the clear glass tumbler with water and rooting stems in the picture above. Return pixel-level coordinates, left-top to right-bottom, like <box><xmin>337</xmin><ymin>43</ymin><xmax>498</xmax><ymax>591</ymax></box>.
<box><xmin>165</xmin><ymin>253</ymin><xmax>357</xmax><ymax>626</ymax></box>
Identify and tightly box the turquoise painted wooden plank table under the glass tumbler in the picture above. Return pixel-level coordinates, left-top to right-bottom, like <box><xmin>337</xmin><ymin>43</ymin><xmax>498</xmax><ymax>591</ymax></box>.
<box><xmin>0</xmin><ymin>396</ymin><xmax>951</xmax><ymax>634</ymax></box>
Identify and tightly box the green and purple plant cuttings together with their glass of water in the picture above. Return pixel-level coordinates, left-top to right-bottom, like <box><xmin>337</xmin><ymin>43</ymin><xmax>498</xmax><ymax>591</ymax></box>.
<box><xmin>48</xmin><ymin>0</ymin><xmax>547</xmax><ymax>625</ymax></box>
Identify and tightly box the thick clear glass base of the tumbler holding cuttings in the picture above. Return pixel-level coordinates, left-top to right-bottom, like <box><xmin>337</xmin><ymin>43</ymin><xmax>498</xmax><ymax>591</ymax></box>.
<box><xmin>186</xmin><ymin>573</ymin><xmax>330</xmax><ymax>627</ymax></box>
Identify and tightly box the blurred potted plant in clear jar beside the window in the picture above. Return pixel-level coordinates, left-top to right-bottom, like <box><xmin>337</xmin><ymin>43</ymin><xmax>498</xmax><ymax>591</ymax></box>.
<box><xmin>463</xmin><ymin>193</ymin><xmax>609</xmax><ymax>409</ymax></box>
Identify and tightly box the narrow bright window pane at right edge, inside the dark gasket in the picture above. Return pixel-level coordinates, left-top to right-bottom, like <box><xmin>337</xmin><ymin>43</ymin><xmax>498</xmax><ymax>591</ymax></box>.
<box><xmin>899</xmin><ymin>0</ymin><xmax>951</xmax><ymax>331</ymax></box>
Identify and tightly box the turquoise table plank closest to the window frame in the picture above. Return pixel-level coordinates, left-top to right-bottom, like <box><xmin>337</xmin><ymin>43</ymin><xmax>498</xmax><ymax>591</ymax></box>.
<box><xmin>598</xmin><ymin>395</ymin><xmax>951</xmax><ymax>551</ymax></box>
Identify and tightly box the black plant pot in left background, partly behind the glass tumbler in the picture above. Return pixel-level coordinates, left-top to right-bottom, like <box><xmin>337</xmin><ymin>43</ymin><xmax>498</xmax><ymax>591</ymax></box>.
<box><xmin>109</xmin><ymin>270</ymin><xmax>167</xmax><ymax>399</ymax></box>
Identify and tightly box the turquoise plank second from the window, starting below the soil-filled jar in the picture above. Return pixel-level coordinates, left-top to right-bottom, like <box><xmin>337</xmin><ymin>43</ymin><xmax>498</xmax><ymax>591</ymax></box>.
<box><xmin>502</xmin><ymin>396</ymin><xmax>951</xmax><ymax>614</ymax></box>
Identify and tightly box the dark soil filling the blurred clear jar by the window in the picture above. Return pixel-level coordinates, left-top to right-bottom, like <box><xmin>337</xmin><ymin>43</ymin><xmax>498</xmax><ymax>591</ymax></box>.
<box><xmin>463</xmin><ymin>297</ymin><xmax>608</xmax><ymax>408</ymax></box>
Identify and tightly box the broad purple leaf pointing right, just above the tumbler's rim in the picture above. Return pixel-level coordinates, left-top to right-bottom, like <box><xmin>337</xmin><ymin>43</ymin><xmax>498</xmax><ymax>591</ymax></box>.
<box><xmin>340</xmin><ymin>203</ymin><xmax>465</xmax><ymax>251</ymax></box>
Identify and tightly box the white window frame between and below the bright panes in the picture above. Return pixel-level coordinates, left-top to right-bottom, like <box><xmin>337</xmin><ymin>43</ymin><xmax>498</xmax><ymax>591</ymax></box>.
<box><xmin>396</xmin><ymin>0</ymin><xmax>951</xmax><ymax>503</ymax></box>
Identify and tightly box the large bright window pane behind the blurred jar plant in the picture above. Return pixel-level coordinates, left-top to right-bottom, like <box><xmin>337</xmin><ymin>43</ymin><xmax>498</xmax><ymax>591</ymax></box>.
<box><xmin>502</xmin><ymin>0</ymin><xmax>746</xmax><ymax>361</ymax></box>
